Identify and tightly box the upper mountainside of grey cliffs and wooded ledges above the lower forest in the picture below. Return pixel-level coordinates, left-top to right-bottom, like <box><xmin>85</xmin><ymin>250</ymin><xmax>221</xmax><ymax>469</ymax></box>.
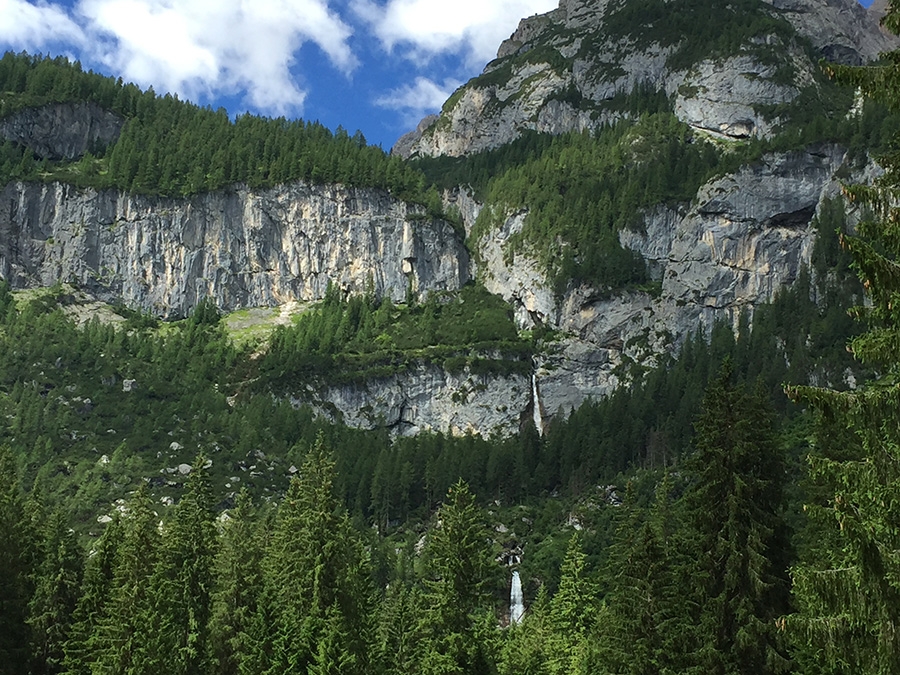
<box><xmin>0</xmin><ymin>0</ymin><xmax>895</xmax><ymax>434</ymax></box>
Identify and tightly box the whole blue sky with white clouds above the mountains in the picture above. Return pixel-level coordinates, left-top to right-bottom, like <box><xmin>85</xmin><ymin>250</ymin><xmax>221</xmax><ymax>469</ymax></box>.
<box><xmin>0</xmin><ymin>0</ymin><xmax>884</xmax><ymax>149</ymax></box>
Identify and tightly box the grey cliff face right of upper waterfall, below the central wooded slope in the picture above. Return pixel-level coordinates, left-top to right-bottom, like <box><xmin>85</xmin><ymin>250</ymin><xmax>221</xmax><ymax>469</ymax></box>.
<box><xmin>478</xmin><ymin>145</ymin><xmax>844</xmax><ymax>422</ymax></box>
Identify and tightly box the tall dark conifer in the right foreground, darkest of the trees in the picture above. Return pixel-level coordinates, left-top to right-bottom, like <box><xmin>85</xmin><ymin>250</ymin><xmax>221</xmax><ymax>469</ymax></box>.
<box><xmin>684</xmin><ymin>361</ymin><xmax>789</xmax><ymax>675</ymax></box>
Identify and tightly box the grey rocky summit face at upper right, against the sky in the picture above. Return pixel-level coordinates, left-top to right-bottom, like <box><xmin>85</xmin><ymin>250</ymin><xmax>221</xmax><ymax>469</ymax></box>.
<box><xmin>395</xmin><ymin>0</ymin><xmax>898</xmax><ymax>157</ymax></box>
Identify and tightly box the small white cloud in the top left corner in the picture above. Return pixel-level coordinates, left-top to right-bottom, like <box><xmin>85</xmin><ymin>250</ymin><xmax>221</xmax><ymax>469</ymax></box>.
<box><xmin>0</xmin><ymin>0</ymin><xmax>85</xmax><ymax>51</ymax></box>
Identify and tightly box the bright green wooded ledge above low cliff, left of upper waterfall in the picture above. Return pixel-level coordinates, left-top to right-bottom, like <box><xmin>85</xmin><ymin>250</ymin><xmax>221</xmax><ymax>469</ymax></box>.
<box><xmin>260</xmin><ymin>285</ymin><xmax>532</xmax><ymax>390</ymax></box>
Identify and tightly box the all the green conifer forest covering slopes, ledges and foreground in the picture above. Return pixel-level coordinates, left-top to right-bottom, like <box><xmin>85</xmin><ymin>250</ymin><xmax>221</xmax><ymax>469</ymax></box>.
<box><xmin>0</xmin><ymin>0</ymin><xmax>900</xmax><ymax>675</ymax></box>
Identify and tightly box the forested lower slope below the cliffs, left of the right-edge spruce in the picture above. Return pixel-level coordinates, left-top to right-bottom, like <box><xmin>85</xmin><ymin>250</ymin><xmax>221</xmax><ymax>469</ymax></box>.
<box><xmin>0</xmin><ymin>180</ymin><xmax>880</xmax><ymax>675</ymax></box>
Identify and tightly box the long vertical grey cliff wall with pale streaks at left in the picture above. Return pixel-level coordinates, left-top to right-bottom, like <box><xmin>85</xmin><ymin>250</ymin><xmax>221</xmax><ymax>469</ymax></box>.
<box><xmin>0</xmin><ymin>183</ymin><xmax>469</xmax><ymax>318</ymax></box>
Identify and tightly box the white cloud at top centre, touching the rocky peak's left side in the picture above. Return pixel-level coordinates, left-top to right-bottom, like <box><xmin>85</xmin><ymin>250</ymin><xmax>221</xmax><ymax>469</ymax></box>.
<box><xmin>352</xmin><ymin>0</ymin><xmax>559</xmax><ymax>65</ymax></box>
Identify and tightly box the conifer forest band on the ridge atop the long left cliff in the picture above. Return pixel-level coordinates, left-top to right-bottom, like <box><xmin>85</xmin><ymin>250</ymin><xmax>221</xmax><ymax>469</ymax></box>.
<box><xmin>0</xmin><ymin>52</ymin><xmax>442</xmax><ymax>216</ymax></box>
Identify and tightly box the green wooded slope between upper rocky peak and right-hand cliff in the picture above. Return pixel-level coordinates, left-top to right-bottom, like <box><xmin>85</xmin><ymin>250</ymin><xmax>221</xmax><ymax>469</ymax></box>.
<box><xmin>472</xmin><ymin>114</ymin><xmax>719</xmax><ymax>290</ymax></box>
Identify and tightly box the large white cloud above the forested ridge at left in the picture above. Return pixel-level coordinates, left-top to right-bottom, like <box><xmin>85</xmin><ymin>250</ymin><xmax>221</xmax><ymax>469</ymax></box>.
<box><xmin>0</xmin><ymin>0</ymin><xmax>357</xmax><ymax>115</ymax></box>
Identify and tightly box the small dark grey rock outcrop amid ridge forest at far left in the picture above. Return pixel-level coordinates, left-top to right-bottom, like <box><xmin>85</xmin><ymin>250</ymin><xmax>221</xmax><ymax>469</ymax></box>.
<box><xmin>0</xmin><ymin>103</ymin><xmax>125</xmax><ymax>159</ymax></box>
